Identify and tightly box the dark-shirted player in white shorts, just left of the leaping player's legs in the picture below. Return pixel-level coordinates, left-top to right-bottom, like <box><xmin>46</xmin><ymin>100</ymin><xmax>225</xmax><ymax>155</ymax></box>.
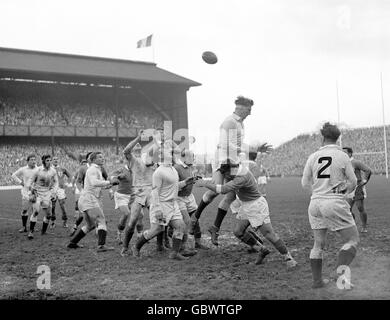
<box><xmin>174</xmin><ymin>150</ymin><xmax>209</xmax><ymax>255</ymax></box>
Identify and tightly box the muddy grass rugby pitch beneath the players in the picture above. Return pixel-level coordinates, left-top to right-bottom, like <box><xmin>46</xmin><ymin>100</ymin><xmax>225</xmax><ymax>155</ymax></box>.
<box><xmin>0</xmin><ymin>176</ymin><xmax>390</xmax><ymax>300</ymax></box>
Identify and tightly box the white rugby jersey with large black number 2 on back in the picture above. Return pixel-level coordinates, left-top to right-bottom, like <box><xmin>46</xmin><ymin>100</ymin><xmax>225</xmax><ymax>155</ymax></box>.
<box><xmin>302</xmin><ymin>144</ymin><xmax>356</xmax><ymax>199</ymax></box>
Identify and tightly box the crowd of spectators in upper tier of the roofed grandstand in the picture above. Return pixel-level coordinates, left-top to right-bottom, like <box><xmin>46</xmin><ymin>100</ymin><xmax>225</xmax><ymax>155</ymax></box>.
<box><xmin>0</xmin><ymin>97</ymin><xmax>164</xmax><ymax>129</ymax></box>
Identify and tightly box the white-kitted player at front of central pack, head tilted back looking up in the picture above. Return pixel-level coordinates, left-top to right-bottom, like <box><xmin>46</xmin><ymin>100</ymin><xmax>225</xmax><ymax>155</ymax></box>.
<box><xmin>132</xmin><ymin>141</ymin><xmax>194</xmax><ymax>260</ymax></box>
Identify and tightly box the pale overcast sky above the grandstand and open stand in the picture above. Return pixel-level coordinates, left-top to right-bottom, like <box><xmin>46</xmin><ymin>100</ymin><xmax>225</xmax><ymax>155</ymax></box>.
<box><xmin>0</xmin><ymin>0</ymin><xmax>390</xmax><ymax>153</ymax></box>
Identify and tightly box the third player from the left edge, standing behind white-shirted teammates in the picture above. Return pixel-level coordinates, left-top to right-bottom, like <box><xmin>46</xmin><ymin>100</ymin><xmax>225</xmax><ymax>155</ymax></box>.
<box><xmin>50</xmin><ymin>157</ymin><xmax>71</xmax><ymax>228</ymax></box>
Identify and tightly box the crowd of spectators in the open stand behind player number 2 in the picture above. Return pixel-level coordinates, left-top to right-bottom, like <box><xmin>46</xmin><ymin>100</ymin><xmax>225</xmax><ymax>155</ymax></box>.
<box><xmin>261</xmin><ymin>126</ymin><xmax>390</xmax><ymax>176</ymax></box>
